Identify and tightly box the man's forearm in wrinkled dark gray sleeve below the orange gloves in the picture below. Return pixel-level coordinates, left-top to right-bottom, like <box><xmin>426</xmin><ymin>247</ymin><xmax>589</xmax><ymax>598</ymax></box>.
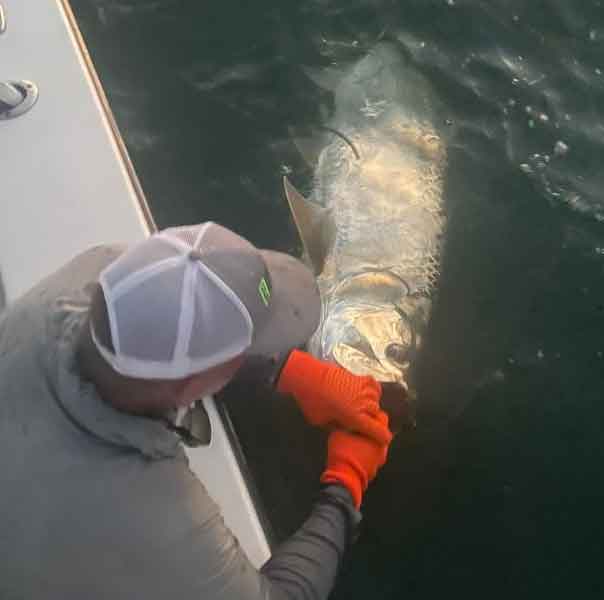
<box><xmin>262</xmin><ymin>485</ymin><xmax>361</xmax><ymax>600</ymax></box>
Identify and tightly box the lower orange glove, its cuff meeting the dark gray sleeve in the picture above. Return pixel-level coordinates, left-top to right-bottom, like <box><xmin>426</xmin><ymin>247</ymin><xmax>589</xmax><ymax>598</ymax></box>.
<box><xmin>321</xmin><ymin>411</ymin><xmax>390</xmax><ymax>509</ymax></box>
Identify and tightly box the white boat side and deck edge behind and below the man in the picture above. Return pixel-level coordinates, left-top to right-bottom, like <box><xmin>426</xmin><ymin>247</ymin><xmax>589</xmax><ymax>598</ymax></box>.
<box><xmin>0</xmin><ymin>0</ymin><xmax>270</xmax><ymax>567</ymax></box>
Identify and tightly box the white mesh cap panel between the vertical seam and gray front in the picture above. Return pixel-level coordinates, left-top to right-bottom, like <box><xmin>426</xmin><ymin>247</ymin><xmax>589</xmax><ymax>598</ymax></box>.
<box><xmin>188</xmin><ymin>263</ymin><xmax>253</xmax><ymax>368</ymax></box>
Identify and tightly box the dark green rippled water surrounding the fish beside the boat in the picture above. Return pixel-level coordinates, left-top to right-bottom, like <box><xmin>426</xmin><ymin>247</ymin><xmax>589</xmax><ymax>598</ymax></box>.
<box><xmin>72</xmin><ymin>0</ymin><xmax>604</xmax><ymax>599</ymax></box>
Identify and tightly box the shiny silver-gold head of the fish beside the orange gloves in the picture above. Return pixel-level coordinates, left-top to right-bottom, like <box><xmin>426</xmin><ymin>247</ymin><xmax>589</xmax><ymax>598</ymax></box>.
<box><xmin>318</xmin><ymin>271</ymin><xmax>415</xmax><ymax>387</ymax></box>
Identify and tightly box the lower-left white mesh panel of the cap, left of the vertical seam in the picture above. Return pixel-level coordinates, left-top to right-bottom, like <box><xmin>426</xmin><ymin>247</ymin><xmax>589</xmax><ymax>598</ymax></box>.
<box><xmin>114</xmin><ymin>262</ymin><xmax>185</xmax><ymax>363</ymax></box>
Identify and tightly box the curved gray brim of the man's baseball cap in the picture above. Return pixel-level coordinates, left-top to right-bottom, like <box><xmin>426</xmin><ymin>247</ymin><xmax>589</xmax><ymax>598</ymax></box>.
<box><xmin>246</xmin><ymin>250</ymin><xmax>321</xmax><ymax>357</ymax></box>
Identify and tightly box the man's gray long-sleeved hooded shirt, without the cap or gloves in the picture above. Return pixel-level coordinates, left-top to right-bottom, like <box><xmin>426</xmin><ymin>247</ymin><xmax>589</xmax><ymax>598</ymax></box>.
<box><xmin>0</xmin><ymin>247</ymin><xmax>358</xmax><ymax>600</ymax></box>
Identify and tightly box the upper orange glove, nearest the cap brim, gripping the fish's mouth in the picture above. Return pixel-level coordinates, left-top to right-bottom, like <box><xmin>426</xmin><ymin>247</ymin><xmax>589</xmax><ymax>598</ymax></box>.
<box><xmin>277</xmin><ymin>350</ymin><xmax>392</xmax><ymax>444</ymax></box>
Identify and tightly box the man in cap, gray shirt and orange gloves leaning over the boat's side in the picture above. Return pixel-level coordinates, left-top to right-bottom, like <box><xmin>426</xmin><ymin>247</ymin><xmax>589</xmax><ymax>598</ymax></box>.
<box><xmin>0</xmin><ymin>223</ymin><xmax>392</xmax><ymax>600</ymax></box>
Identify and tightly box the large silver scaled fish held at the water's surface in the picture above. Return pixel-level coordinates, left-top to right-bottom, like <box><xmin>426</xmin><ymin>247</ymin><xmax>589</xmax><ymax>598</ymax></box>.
<box><xmin>283</xmin><ymin>41</ymin><xmax>447</xmax><ymax>391</ymax></box>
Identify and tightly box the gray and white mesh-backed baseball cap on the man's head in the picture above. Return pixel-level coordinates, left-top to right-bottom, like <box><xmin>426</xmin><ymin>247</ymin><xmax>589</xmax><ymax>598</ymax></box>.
<box><xmin>91</xmin><ymin>222</ymin><xmax>321</xmax><ymax>379</ymax></box>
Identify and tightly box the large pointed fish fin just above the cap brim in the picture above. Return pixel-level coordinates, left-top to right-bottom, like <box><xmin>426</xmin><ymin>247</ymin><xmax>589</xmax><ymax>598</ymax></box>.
<box><xmin>283</xmin><ymin>177</ymin><xmax>333</xmax><ymax>274</ymax></box>
